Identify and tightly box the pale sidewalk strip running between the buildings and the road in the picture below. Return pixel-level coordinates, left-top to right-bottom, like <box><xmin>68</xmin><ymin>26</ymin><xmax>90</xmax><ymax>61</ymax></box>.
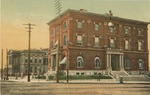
<box><xmin>3</xmin><ymin>76</ymin><xmax>150</xmax><ymax>84</ymax></box>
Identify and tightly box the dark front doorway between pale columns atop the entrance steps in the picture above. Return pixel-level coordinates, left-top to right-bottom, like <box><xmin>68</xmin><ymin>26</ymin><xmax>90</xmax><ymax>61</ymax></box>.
<box><xmin>111</xmin><ymin>54</ymin><xmax>120</xmax><ymax>71</ymax></box>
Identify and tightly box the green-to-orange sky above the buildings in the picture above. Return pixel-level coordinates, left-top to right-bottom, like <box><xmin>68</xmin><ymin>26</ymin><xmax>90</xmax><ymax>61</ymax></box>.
<box><xmin>0</xmin><ymin>0</ymin><xmax>150</xmax><ymax>68</ymax></box>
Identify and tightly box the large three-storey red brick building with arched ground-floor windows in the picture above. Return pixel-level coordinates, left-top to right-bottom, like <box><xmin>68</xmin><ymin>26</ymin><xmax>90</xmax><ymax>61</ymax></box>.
<box><xmin>48</xmin><ymin>9</ymin><xmax>149</xmax><ymax>75</ymax></box>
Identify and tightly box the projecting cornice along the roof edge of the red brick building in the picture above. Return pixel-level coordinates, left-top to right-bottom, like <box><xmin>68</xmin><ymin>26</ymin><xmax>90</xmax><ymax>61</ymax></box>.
<box><xmin>47</xmin><ymin>9</ymin><xmax>150</xmax><ymax>25</ymax></box>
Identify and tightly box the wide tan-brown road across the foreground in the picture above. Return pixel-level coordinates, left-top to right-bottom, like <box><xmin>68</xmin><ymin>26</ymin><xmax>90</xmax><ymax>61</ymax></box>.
<box><xmin>1</xmin><ymin>81</ymin><xmax>150</xmax><ymax>95</ymax></box>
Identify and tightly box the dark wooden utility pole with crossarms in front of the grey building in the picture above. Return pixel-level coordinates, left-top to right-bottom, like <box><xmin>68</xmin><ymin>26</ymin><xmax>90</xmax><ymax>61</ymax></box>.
<box><xmin>23</xmin><ymin>23</ymin><xmax>35</xmax><ymax>82</ymax></box>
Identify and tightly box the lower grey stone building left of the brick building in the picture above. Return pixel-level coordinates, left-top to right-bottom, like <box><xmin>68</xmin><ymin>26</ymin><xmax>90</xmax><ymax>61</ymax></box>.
<box><xmin>8</xmin><ymin>49</ymin><xmax>48</xmax><ymax>74</ymax></box>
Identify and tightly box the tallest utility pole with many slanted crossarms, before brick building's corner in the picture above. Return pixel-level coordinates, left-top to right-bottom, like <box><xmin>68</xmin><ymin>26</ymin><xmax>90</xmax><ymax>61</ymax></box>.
<box><xmin>55</xmin><ymin>0</ymin><xmax>62</xmax><ymax>83</ymax></box>
